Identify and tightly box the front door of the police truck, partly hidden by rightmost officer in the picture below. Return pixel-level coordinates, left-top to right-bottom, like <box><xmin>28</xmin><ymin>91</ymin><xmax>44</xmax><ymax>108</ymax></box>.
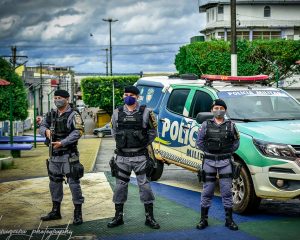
<box><xmin>181</xmin><ymin>88</ymin><xmax>215</xmax><ymax>169</ymax></box>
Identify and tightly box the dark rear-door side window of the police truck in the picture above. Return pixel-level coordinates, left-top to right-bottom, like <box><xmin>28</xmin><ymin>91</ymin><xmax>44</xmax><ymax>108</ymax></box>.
<box><xmin>167</xmin><ymin>89</ymin><xmax>190</xmax><ymax>115</ymax></box>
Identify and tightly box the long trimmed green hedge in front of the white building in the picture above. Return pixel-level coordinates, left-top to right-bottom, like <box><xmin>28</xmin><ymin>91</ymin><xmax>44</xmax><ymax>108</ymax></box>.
<box><xmin>175</xmin><ymin>39</ymin><xmax>300</xmax><ymax>79</ymax></box>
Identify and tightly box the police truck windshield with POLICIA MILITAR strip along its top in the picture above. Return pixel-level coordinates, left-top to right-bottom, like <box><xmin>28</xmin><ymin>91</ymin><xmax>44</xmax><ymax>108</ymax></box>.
<box><xmin>218</xmin><ymin>90</ymin><xmax>300</xmax><ymax>121</ymax></box>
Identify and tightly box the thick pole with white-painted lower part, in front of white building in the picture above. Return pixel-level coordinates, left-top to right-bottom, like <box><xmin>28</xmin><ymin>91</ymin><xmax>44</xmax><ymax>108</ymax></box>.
<box><xmin>230</xmin><ymin>0</ymin><xmax>237</xmax><ymax>76</ymax></box>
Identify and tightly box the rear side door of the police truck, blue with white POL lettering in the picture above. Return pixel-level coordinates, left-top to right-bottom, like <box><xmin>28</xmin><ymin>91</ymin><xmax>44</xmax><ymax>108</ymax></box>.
<box><xmin>158</xmin><ymin>87</ymin><xmax>190</xmax><ymax>162</ymax></box>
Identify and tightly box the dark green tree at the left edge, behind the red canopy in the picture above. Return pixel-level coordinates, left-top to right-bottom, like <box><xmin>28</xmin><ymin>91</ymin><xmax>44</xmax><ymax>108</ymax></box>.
<box><xmin>0</xmin><ymin>58</ymin><xmax>28</xmax><ymax>121</ymax></box>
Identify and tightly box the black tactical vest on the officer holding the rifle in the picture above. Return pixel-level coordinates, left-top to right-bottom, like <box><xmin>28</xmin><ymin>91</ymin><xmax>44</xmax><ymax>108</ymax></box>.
<box><xmin>47</xmin><ymin>110</ymin><xmax>78</xmax><ymax>150</ymax></box>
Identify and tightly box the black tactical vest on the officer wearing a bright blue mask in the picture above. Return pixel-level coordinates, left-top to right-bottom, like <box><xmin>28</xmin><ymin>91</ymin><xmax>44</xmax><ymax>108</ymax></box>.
<box><xmin>115</xmin><ymin>105</ymin><xmax>148</xmax><ymax>150</ymax></box>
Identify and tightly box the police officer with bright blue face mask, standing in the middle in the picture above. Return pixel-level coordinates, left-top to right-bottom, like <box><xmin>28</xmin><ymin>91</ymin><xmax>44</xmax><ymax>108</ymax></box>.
<box><xmin>107</xmin><ymin>86</ymin><xmax>160</xmax><ymax>229</ymax></box>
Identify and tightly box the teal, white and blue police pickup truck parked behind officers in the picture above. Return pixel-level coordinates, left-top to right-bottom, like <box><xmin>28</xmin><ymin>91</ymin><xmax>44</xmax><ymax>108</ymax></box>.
<box><xmin>136</xmin><ymin>74</ymin><xmax>300</xmax><ymax>213</ymax></box>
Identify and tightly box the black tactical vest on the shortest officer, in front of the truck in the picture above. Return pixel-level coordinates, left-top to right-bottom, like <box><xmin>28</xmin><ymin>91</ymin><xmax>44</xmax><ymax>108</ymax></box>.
<box><xmin>204</xmin><ymin>120</ymin><xmax>234</xmax><ymax>154</ymax></box>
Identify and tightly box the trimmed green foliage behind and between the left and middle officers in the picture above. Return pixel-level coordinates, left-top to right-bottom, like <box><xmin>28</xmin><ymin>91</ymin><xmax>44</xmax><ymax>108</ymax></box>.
<box><xmin>81</xmin><ymin>76</ymin><xmax>139</xmax><ymax>114</ymax></box>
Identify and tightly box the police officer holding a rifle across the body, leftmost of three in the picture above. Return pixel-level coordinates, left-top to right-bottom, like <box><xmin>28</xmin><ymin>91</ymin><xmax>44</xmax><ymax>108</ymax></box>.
<box><xmin>40</xmin><ymin>90</ymin><xmax>84</xmax><ymax>225</ymax></box>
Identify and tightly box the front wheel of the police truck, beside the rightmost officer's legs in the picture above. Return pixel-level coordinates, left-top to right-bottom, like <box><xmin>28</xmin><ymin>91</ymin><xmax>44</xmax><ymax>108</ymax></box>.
<box><xmin>232</xmin><ymin>162</ymin><xmax>261</xmax><ymax>214</ymax></box>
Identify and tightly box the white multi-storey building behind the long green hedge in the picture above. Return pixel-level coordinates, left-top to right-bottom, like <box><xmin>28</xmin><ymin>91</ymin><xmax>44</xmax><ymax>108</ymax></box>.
<box><xmin>199</xmin><ymin>0</ymin><xmax>300</xmax><ymax>41</ymax></box>
